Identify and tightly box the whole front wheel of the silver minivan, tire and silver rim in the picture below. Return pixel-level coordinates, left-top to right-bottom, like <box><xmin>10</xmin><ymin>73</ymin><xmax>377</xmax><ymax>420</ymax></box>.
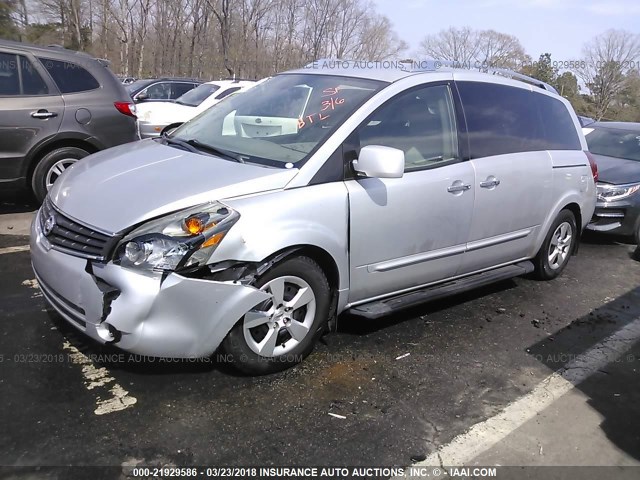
<box><xmin>222</xmin><ymin>256</ymin><xmax>331</xmax><ymax>375</ymax></box>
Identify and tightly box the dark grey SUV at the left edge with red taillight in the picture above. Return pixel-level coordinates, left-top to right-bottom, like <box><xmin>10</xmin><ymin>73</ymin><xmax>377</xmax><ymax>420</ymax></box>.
<box><xmin>0</xmin><ymin>40</ymin><xmax>137</xmax><ymax>201</ymax></box>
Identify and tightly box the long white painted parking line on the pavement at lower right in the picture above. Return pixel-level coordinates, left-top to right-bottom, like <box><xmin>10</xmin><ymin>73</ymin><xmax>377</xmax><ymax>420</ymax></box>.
<box><xmin>400</xmin><ymin>318</ymin><xmax>640</xmax><ymax>472</ymax></box>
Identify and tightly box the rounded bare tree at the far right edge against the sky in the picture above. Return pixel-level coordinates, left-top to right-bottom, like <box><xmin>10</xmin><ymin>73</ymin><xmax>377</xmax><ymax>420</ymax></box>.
<box><xmin>575</xmin><ymin>30</ymin><xmax>640</xmax><ymax>120</ymax></box>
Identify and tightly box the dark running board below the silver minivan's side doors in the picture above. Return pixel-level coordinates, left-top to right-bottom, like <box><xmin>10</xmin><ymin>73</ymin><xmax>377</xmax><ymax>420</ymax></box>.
<box><xmin>348</xmin><ymin>260</ymin><xmax>534</xmax><ymax>319</ymax></box>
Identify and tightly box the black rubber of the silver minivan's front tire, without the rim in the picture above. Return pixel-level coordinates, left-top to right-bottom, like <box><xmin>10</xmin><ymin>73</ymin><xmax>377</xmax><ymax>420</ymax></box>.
<box><xmin>222</xmin><ymin>256</ymin><xmax>331</xmax><ymax>375</ymax></box>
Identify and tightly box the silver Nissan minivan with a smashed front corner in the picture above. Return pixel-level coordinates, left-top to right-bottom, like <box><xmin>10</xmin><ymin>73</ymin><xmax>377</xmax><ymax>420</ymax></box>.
<box><xmin>31</xmin><ymin>62</ymin><xmax>597</xmax><ymax>374</ymax></box>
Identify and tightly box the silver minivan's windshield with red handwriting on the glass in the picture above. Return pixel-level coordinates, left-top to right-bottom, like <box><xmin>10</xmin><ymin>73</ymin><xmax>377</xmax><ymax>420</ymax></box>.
<box><xmin>170</xmin><ymin>74</ymin><xmax>386</xmax><ymax>168</ymax></box>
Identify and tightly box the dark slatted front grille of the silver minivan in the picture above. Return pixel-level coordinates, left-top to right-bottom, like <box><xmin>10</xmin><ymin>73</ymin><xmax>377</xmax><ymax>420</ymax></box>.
<box><xmin>40</xmin><ymin>197</ymin><xmax>118</xmax><ymax>261</ymax></box>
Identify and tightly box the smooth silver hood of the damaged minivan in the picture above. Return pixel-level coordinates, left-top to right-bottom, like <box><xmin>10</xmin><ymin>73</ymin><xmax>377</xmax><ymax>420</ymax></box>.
<box><xmin>49</xmin><ymin>140</ymin><xmax>298</xmax><ymax>232</ymax></box>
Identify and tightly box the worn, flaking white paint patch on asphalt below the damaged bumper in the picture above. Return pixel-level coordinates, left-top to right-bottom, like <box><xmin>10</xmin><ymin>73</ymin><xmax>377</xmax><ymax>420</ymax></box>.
<box><xmin>62</xmin><ymin>340</ymin><xmax>138</xmax><ymax>415</ymax></box>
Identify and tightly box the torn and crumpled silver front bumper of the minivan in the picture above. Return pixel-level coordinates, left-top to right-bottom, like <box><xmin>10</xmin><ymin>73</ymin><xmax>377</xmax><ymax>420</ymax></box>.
<box><xmin>31</xmin><ymin>213</ymin><xmax>270</xmax><ymax>358</ymax></box>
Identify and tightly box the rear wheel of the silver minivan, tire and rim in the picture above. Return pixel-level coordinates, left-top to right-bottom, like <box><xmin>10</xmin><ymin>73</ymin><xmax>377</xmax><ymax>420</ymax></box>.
<box><xmin>534</xmin><ymin>210</ymin><xmax>578</xmax><ymax>280</ymax></box>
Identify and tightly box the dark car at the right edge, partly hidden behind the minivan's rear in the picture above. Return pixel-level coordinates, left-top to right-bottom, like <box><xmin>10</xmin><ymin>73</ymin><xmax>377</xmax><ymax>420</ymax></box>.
<box><xmin>583</xmin><ymin>122</ymin><xmax>640</xmax><ymax>243</ymax></box>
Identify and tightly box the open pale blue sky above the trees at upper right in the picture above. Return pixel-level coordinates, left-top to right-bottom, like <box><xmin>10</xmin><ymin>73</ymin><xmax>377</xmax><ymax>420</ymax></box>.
<box><xmin>375</xmin><ymin>0</ymin><xmax>640</xmax><ymax>61</ymax></box>
